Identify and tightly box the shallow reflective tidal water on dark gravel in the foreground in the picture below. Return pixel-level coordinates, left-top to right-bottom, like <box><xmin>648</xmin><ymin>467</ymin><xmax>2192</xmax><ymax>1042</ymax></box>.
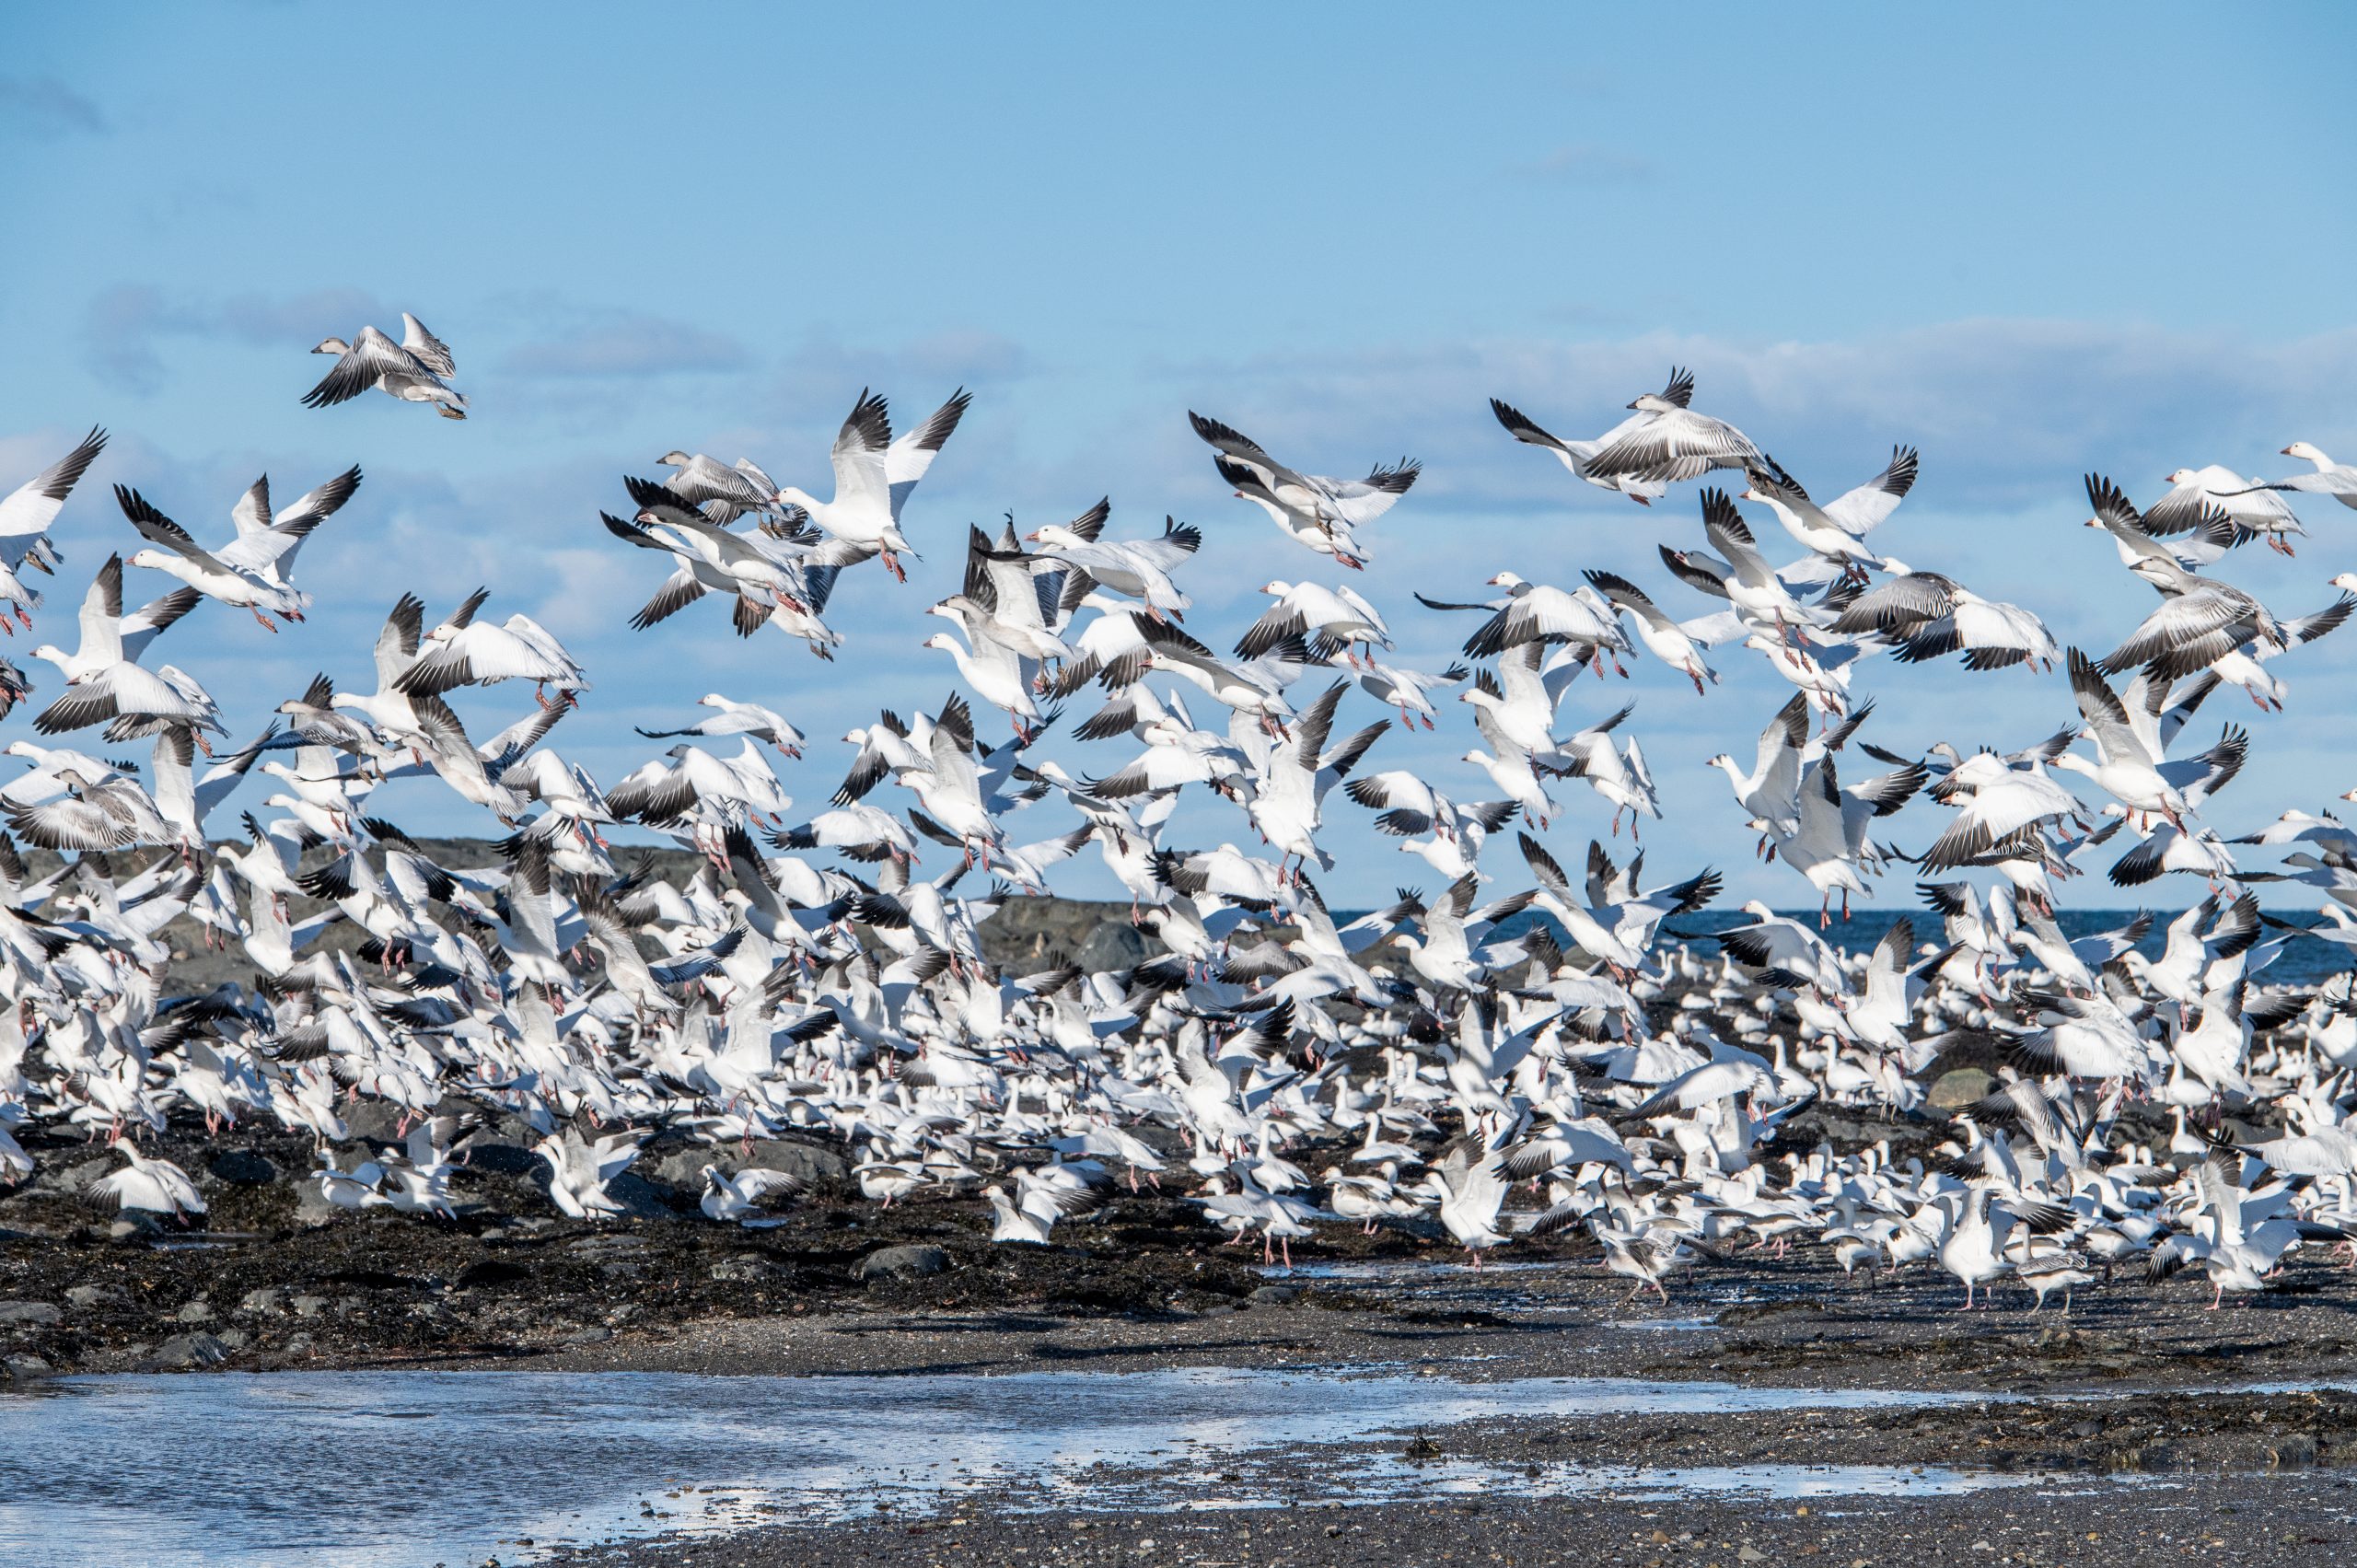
<box><xmin>0</xmin><ymin>1367</ymin><xmax>2140</xmax><ymax>1568</ymax></box>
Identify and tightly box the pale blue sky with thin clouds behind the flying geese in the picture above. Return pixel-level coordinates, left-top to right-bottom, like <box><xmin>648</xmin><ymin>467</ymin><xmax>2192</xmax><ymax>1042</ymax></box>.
<box><xmin>0</xmin><ymin>5</ymin><xmax>2357</xmax><ymax>903</ymax></box>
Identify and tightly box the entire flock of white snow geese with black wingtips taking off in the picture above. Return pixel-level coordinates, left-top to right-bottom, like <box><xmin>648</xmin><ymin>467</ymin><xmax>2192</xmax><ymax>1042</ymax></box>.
<box><xmin>14</xmin><ymin>316</ymin><xmax>2357</xmax><ymax>1307</ymax></box>
